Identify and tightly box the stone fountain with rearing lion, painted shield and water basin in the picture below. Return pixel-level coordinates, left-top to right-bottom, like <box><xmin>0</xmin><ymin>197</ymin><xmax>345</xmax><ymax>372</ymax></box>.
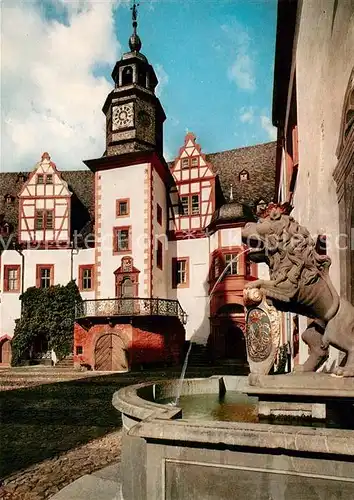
<box><xmin>113</xmin><ymin>204</ymin><xmax>354</xmax><ymax>500</ymax></box>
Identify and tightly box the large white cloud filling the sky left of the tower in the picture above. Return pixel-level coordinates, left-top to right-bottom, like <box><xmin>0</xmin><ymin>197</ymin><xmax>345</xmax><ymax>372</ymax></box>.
<box><xmin>1</xmin><ymin>0</ymin><xmax>122</xmax><ymax>170</ymax></box>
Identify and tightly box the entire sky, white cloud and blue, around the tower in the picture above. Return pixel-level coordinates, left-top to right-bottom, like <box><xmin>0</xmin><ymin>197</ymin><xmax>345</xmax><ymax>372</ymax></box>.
<box><xmin>0</xmin><ymin>0</ymin><xmax>276</xmax><ymax>171</ymax></box>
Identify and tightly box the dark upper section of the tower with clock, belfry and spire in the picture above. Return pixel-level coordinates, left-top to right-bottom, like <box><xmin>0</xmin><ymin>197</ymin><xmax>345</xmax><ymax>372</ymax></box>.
<box><xmin>103</xmin><ymin>3</ymin><xmax>166</xmax><ymax>156</ymax></box>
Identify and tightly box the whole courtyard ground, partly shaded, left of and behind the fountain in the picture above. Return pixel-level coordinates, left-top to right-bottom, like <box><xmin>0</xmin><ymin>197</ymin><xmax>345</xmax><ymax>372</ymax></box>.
<box><xmin>0</xmin><ymin>366</ymin><xmax>241</xmax><ymax>500</ymax></box>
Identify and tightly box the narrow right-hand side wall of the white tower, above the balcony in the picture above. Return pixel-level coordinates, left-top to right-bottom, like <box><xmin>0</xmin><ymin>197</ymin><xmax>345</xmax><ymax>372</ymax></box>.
<box><xmin>152</xmin><ymin>166</ymin><xmax>171</xmax><ymax>298</ymax></box>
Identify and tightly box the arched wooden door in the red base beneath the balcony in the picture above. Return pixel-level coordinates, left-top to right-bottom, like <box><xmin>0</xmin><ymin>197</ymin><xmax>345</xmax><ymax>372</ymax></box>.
<box><xmin>95</xmin><ymin>333</ymin><xmax>128</xmax><ymax>371</ymax></box>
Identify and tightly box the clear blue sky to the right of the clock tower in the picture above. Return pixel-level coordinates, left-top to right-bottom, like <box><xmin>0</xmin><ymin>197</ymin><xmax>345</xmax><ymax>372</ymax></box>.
<box><xmin>116</xmin><ymin>0</ymin><xmax>276</xmax><ymax>153</ymax></box>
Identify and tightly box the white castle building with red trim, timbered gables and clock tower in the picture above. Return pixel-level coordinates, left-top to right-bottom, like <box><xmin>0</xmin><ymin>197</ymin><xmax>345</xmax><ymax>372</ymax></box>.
<box><xmin>0</xmin><ymin>9</ymin><xmax>276</xmax><ymax>370</ymax></box>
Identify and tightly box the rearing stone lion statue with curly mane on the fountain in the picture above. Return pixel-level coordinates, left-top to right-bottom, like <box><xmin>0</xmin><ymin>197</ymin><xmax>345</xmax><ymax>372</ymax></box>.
<box><xmin>242</xmin><ymin>203</ymin><xmax>354</xmax><ymax>377</ymax></box>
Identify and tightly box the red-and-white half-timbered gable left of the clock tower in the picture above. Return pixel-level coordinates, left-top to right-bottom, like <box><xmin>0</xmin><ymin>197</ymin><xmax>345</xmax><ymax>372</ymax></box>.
<box><xmin>18</xmin><ymin>153</ymin><xmax>72</xmax><ymax>245</ymax></box>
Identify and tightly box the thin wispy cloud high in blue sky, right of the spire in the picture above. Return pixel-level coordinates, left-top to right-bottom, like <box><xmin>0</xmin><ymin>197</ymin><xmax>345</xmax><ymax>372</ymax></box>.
<box><xmin>221</xmin><ymin>22</ymin><xmax>257</xmax><ymax>91</ymax></box>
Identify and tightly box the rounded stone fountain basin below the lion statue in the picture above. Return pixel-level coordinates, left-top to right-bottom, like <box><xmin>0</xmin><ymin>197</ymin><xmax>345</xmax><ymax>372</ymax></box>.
<box><xmin>113</xmin><ymin>376</ymin><xmax>354</xmax><ymax>500</ymax></box>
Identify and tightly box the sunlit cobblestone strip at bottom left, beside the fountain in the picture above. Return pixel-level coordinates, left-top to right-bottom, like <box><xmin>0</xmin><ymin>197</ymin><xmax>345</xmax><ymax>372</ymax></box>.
<box><xmin>0</xmin><ymin>431</ymin><xmax>121</xmax><ymax>500</ymax></box>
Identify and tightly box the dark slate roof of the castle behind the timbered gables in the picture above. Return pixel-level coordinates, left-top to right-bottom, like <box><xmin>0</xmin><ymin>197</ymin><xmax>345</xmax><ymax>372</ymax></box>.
<box><xmin>0</xmin><ymin>142</ymin><xmax>276</xmax><ymax>232</ymax></box>
